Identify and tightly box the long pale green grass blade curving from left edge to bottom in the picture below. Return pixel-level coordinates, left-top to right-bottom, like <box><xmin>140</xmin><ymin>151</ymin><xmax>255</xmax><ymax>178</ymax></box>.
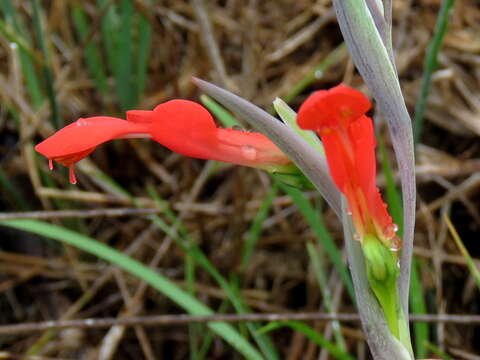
<box><xmin>0</xmin><ymin>220</ymin><xmax>262</xmax><ymax>360</ymax></box>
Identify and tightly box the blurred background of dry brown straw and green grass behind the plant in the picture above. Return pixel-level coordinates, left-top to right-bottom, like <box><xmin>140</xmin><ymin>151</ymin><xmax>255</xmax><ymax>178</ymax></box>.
<box><xmin>0</xmin><ymin>0</ymin><xmax>480</xmax><ymax>360</ymax></box>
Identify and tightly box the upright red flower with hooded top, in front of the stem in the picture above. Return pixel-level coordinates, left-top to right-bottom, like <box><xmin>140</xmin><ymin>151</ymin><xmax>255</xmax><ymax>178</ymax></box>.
<box><xmin>297</xmin><ymin>85</ymin><xmax>400</xmax><ymax>249</ymax></box>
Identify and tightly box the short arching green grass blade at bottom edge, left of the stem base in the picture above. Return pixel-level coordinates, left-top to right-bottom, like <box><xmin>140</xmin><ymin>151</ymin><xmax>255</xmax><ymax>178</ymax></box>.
<box><xmin>260</xmin><ymin>321</ymin><xmax>355</xmax><ymax>360</ymax></box>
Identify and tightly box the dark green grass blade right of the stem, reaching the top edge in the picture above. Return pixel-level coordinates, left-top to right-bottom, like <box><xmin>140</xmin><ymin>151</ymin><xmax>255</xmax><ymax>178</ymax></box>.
<box><xmin>413</xmin><ymin>0</ymin><xmax>455</xmax><ymax>144</ymax></box>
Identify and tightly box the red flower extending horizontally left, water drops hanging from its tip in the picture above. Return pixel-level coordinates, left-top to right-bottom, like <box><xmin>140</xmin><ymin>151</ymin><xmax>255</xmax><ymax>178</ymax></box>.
<box><xmin>35</xmin><ymin>100</ymin><xmax>290</xmax><ymax>183</ymax></box>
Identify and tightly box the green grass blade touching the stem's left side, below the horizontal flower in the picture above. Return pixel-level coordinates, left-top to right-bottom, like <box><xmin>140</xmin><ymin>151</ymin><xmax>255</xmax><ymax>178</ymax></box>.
<box><xmin>279</xmin><ymin>183</ymin><xmax>355</xmax><ymax>301</ymax></box>
